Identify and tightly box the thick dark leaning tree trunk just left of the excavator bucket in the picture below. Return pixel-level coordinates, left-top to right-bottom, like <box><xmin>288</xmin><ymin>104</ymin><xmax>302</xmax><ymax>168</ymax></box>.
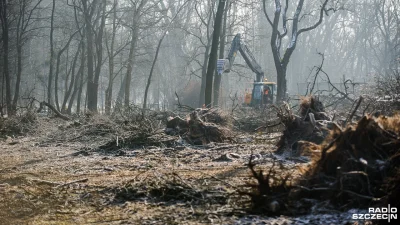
<box><xmin>205</xmin><ymin>0</ymin><xmax>225</xmax><ymax>107</ymax></box>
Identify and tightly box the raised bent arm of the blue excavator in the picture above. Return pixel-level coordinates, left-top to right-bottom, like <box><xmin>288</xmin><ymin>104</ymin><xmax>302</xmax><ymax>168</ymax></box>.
<box><xmin>224</xmin><ymin>34</ymin><xmax>264</xmax><ymax>82</ymax></box>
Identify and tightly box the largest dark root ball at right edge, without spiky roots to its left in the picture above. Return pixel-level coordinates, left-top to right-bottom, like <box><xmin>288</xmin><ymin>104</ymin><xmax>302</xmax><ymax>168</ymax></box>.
<box><xmin>304</xmin><ymin>115</ymin><xmax>400</xmax><ymax>211</ymax></box>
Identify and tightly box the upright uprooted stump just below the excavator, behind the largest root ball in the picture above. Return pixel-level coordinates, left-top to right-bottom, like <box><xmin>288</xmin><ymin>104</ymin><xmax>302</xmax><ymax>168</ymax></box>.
<box><xmin>274</xmin><ymin>96</ymin><xmax>331</xmax><ymax>155</ymax></box>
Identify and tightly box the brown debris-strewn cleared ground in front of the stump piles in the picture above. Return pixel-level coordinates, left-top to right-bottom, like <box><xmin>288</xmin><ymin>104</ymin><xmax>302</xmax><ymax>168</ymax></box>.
<box><xmin>0</xmin><ymin>118</ymin><xmax>368</xmax><ymax>224</ymax></box>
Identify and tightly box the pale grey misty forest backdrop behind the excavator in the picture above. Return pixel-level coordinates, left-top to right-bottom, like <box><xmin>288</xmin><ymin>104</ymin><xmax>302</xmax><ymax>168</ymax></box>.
<box><xmin>0</xmin><ymin>0</ymin><xmax>400</xmax><ymax>114</ymax></box>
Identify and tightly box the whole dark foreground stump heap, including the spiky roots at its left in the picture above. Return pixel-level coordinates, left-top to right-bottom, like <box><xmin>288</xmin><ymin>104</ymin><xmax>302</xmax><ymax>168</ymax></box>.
<box><xmin>245</xmin><ymin>114</ymin><xmax>400</xmax><ymax>219</ymax></box>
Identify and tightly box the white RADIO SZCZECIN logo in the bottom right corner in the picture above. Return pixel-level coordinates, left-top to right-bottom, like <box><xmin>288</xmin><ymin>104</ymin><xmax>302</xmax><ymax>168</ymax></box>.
<box><xmin>351</xmin><ymin>204</ymin><xmax>397</xmax><ymax>223</ymax></box>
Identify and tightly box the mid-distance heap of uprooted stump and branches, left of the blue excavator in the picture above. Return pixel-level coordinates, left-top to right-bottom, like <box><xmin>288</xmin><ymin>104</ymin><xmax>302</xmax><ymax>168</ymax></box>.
<box><xmin>165</xmin><ymin>108</ymin><xmax>231</xmax><ymax>145</ymax></box>
